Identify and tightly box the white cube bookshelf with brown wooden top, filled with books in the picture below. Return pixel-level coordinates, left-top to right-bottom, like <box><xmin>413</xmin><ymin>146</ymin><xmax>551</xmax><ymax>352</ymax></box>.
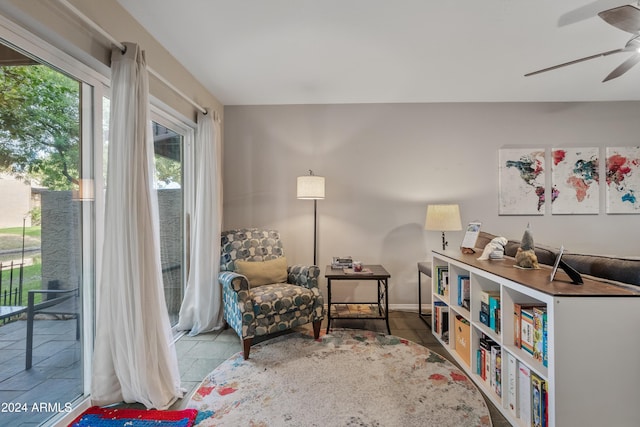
<box><xmin>432</xmin><ymin>251</ymin><xmax>640</xmax><ymax>427</ymax></box>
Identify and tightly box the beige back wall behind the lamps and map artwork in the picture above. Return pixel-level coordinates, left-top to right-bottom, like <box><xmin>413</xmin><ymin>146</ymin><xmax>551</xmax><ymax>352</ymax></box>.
<box><xmin>224</xmin><ymin>102</ymin><xmax>640</xmax><ymax>304</ymax></box>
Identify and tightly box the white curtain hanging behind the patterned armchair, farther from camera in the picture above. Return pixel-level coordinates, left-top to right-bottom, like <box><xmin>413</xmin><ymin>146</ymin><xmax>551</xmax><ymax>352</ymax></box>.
<box><xmin>177</xmin><ymin>112</ymin><xmax>224</xmax><ymax>335</ymax></box>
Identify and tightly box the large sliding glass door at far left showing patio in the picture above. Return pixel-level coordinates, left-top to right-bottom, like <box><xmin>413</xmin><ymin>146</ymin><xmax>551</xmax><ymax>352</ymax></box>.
<box><xmin>0</xmin><ymin>38</ymin><xmax>95</xmax><ymax>425</ymax></box>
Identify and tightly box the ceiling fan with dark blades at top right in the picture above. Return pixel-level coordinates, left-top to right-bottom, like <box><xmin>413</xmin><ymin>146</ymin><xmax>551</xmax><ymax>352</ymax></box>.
<box><xmin>525</xmin><ymin>5</ymin><xmax>640</xmax><ymax>82</ymax></box>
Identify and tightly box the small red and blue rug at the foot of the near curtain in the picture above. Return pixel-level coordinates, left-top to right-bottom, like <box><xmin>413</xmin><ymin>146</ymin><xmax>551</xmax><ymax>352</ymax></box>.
<box><xmin>69</xmin><ymin>406</ymin><xmax>198</xmax><ymax>427</ymax></box>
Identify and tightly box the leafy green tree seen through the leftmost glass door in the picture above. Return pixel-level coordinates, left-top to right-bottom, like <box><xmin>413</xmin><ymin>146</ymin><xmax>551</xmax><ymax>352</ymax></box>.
<box><xmin>0</xmin><ymin>65</ymin><xmax>80</xmax><ymax>190</ymax></box>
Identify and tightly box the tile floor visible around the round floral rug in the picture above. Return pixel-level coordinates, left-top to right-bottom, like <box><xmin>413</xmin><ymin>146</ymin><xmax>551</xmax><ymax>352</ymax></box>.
<box><xmin>174</xmin><ymin>311</ymin><xmax>510</xmax><ymax>427</ymax></box>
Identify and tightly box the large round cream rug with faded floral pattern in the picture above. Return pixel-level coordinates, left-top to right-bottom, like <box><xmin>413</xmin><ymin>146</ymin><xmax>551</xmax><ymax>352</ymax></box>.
<box><xmin>186</xmin><ymin>329</ymin><xmax>491</xmax><ymax>427</ymax></box>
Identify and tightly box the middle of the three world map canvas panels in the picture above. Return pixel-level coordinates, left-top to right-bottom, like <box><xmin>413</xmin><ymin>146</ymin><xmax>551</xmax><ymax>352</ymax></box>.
<box><xmin>551</xmin><ymin>147</ymin><xmax>600</xmax><ymax>214</ymax></box>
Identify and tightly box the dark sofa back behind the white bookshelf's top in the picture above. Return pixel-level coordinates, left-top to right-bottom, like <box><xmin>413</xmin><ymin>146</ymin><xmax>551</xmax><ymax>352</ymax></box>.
<box><xmin>476</xmin><ymin>231</ymin><xmax>640</xmax><ymax>286</ymax></box>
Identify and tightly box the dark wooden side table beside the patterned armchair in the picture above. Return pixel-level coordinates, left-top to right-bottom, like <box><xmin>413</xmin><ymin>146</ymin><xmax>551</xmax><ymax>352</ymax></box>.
<box><xmin>324</xmin><ymin>264</ymin><xmax>391</xmax><ymax>335</ymax></box>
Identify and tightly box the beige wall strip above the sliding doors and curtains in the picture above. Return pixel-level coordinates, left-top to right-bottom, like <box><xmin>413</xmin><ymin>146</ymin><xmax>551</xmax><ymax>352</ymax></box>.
<box><xmin>0</xmin><ymin>0</ymin><xmax>223</xmax><ymax>121</ymax></box>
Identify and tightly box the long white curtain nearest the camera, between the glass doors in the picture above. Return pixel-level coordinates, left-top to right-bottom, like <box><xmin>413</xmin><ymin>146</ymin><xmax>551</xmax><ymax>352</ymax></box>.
<box><xmin>91</xmin><ymin>43</ymin><xmax>183</xmax><ymax>409</ymax></box>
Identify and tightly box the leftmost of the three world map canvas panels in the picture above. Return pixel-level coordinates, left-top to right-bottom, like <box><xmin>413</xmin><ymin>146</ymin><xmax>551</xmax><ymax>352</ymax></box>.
<box><xmin>499</xmin><ymin>148</ymin><xmax>545</xmax><ymax>215</ymax></box>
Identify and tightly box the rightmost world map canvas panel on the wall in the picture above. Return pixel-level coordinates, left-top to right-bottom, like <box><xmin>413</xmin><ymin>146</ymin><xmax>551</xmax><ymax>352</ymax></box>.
<box><xmin>606</xmin><ymin>147</ymin><xmax>640</xmax><ymax>213</ymax></box>
